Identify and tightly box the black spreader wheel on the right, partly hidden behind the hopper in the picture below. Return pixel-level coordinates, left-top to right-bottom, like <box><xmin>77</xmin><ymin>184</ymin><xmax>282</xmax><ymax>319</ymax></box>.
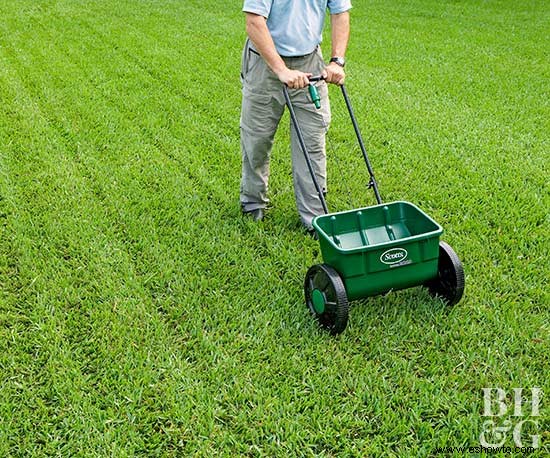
<box><xmin>426</xmin><ymin>241</ymin><xmax>464</xmax><ymax>305</ymax></box>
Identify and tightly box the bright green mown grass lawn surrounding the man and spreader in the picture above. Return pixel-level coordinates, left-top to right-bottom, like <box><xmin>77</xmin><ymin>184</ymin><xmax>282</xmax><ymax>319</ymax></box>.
<box><xmin>0</xmin><ymin>0</ymin><xmax>550</xmax><ymax>457</ymax></box>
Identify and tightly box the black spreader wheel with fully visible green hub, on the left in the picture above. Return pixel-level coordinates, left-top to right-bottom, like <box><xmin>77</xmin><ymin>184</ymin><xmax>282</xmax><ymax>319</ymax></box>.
<box><xmin>304</xmin><ymin>264</ymin><xmax>349</xmax><ymax>335</ymax></box>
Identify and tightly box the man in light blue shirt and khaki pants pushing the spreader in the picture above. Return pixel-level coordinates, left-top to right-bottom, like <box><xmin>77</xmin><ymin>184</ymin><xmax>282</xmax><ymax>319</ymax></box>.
<box><xmin>240</xmin><ymin>0</ymin><xmax>351</xmax><ymax>232</ymax></box>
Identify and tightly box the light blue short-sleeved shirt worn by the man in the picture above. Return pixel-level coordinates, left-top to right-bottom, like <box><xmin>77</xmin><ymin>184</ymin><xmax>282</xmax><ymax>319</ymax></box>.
<box><xmin>243</xmin><ymin>0</ymin><xmax>351</xmax><ymax>57</ymax></box>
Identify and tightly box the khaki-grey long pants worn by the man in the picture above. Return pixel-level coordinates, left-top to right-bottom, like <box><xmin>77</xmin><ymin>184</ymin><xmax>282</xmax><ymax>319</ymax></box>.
<box><xmin>240</xmin><ymin>40</ymin><xmax>330</xmax><ymax>228</ymax></box>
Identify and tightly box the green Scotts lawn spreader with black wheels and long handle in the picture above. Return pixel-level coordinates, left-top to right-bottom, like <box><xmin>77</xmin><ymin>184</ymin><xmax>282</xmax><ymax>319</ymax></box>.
<box><xmin>283</xmin><ymin>76</ymin><xmax>464</xmax><ymax>335</ymax></box>
